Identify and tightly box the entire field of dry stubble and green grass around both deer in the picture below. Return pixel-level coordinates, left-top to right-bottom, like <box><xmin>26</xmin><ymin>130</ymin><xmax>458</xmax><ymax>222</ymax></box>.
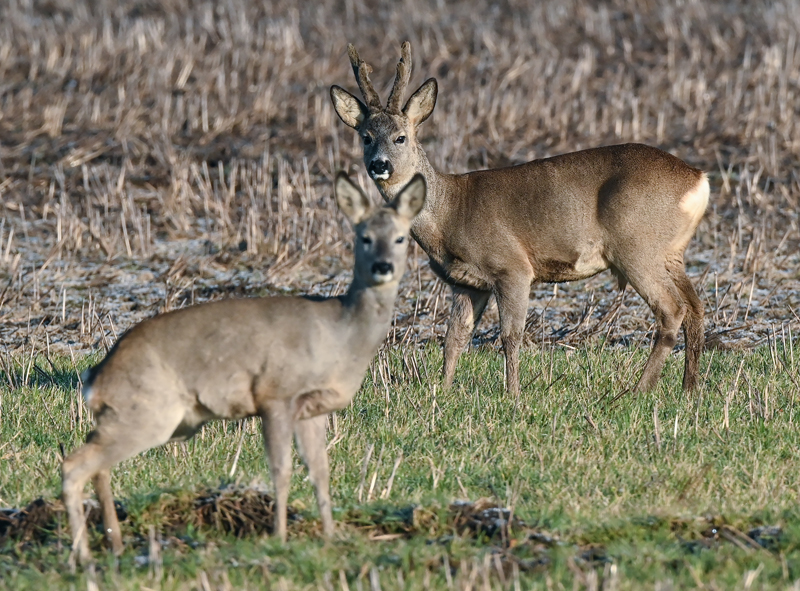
<box><xmin>0</xmin><ymin>0</ymin><xmax>800</xmax><ymax>591</ymax></box>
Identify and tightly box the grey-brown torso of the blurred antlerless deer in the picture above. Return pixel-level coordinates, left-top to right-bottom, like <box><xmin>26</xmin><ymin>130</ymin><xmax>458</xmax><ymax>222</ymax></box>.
<box><xmin>86</xmin><ymin>287</ymin><xmax>395</xmax><ymax>424</ymax></box>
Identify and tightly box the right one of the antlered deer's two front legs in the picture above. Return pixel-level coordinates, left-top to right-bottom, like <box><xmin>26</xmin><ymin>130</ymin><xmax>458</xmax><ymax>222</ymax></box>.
<box><xmin>495</xmin><ymin>277</ymin><xmax>531</xmax><ymax>396</ymax></box>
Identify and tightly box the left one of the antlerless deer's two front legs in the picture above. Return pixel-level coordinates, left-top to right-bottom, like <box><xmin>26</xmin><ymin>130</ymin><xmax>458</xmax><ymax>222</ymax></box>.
<box><xmin>261</xmin><ymin>400</ymin><xmax>294</xmax><ymax>541</ymax></box>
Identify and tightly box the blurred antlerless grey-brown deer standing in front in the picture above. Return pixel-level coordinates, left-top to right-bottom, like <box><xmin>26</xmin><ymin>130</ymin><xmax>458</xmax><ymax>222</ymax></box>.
<box><xmin>62</xmin><ymin>173</ymin><xmax>426</xmax><ymax>565</ymax></box>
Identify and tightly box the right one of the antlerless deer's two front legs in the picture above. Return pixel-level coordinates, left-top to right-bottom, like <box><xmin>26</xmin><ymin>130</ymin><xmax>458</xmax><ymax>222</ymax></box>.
<box><xmin>294</xmin><ymin>415</ymin><xmax>333</xmax><ymax>538</ymax></box>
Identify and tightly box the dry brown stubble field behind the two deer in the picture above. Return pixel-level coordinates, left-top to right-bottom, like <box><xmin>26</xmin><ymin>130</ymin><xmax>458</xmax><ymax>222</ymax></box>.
<box><xmin>0</xmin><ymin>0</ymin><xmax>800</xmax><ymax>353</ymax></box>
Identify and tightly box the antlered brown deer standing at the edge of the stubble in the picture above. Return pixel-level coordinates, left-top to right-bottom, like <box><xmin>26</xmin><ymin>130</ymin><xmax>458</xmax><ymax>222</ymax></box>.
<box><xmin>330</xmin><ymin>41</ymin><xmax>709</xmax><ymax>396</ymax></box>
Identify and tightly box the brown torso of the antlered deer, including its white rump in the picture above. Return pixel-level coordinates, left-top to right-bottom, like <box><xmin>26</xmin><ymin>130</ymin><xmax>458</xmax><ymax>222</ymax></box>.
<box><xmin>396</xmin><ymin>144</ymin><xmax>707</xmax><ymax>290</ymax></box>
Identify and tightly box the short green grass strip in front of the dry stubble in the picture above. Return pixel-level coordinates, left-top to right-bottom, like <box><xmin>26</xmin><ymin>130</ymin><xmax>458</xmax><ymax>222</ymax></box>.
<box><xmin>0</xmin><ymin>343</ymin><xmax>800</xmax><ymax>589</ymax></box>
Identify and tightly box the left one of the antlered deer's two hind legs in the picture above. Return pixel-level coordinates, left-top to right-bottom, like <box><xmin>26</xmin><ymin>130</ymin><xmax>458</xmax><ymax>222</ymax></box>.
<box><xmin>628</xmin><ymin>266</ymin><xmax>687</xmax><ymax>392</ymax></box>
